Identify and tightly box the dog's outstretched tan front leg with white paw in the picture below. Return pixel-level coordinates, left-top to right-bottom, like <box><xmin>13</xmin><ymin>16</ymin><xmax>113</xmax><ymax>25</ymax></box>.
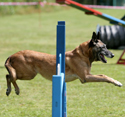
<box><xmin>85</xmin><ymin>74</ymin><xmax>122</xmax><ymax>87</ymax></box>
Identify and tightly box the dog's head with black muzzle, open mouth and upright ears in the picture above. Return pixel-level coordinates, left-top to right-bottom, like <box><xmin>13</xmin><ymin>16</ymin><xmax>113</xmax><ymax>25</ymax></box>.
<box><xmin>89</xmin><ymin>32</ymin><xmax>114</xmax><ymax>63</ymax></box>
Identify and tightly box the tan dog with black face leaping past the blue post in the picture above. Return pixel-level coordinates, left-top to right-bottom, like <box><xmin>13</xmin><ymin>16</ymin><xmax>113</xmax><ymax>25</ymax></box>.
<box><xmin>5</xmin><ymin>32</ymin><xmax>122</xmax><ymax>96</ymax></box>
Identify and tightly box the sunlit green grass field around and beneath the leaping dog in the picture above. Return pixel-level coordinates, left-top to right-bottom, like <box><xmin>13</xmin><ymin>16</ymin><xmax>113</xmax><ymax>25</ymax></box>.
<box><xmin>0</xmin><ymin>7</ymin><xmax>125</xmax><ymax>117</ymax></box>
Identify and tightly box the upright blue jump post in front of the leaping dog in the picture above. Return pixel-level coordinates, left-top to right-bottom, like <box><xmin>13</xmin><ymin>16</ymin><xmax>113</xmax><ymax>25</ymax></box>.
<box><xmin>52</xmin><ymin>21</ymin><xmax>67</xmax><ymax>117</ymax></box>
